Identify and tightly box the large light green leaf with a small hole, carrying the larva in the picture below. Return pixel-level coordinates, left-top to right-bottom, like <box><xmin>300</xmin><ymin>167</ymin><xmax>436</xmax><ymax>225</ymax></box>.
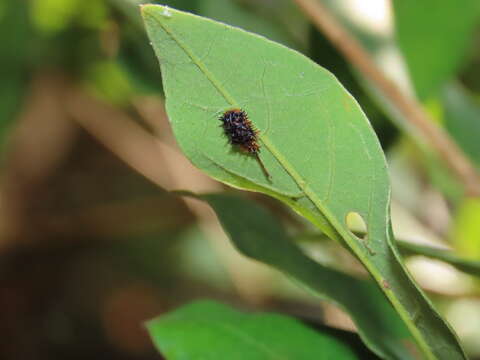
<box><xmin>143</xmin><ymin>5</ymin><xmax>464</xmax><ymax>359</ymax></box>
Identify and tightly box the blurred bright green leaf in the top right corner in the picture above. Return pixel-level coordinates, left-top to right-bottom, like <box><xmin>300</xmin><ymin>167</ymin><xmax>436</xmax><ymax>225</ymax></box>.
<box><xmin>393</xmin><ymin>0</ymin><xmax>480</xmax><ymax>99</ymax></box>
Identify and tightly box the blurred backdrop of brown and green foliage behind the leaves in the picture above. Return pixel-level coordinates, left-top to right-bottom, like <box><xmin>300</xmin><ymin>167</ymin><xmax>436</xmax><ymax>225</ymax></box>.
<box><xmin>0</xmin><ymin>0</ymin><xmax>480</xmax><ymax>360</ymax></box>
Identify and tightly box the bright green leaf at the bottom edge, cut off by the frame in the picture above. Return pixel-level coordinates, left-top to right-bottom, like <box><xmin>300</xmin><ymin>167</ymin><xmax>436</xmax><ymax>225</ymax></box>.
<box><xmin>147</xmin><ymin>301</ymin><xmax>356</xmax><ymax>360</ymax></box>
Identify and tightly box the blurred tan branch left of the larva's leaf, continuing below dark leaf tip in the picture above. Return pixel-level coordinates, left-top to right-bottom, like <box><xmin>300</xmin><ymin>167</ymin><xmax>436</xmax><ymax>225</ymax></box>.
<box><xmin>65</xmin><ymin>85</ymin><xmax>271</xmax><ymax>304</ymax></box>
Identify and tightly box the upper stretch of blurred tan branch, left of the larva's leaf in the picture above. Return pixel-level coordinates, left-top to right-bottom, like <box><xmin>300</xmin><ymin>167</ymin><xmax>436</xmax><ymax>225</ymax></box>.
<box><xmin>65</xmin><ymin>84</ymin><xmax>219</xmax><ymax>192</ymax></box>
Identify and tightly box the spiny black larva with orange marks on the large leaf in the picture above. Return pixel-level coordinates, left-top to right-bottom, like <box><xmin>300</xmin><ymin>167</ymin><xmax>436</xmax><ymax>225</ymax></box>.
<box><xmin>219</xmin><ymin>109</ymin><xmax>270</xmax><ymax>179</ymax></box>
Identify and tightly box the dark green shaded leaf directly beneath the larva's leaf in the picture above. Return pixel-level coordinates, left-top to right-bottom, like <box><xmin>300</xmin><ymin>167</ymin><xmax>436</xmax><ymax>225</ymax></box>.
<box><xmin>200</xmin><ymin>194</ymin><xmax>412</xmax><ymax>360</ymax></box>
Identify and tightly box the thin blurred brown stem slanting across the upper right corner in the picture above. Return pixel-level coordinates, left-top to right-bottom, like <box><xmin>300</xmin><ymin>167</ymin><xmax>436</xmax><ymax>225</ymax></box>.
<box><xmin>295</xmin><ymin>0</ymin><xmax>480</xmax><ymax>196</ymax></box>
